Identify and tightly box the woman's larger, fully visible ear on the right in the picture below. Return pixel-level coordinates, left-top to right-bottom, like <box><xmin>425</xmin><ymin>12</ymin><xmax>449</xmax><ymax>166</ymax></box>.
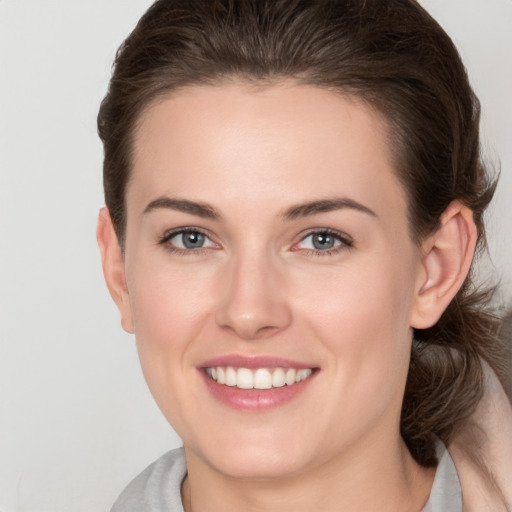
<box><xmin>410</xmin><ymin>201</ymin><xmax>477</xmax><ymax>329</ymax></box>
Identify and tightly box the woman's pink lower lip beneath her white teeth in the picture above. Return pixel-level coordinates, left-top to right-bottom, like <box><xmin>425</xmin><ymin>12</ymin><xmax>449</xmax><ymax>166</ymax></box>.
<box><xmin>201</xmin><ymin>370</ymin><xmax>318</xmax><ymax>411</ymax></box>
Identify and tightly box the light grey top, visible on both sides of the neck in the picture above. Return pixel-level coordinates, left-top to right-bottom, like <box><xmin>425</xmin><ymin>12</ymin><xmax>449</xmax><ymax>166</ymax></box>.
<box><xmin>111</xmin><ymin>442</ymin><xmax>462</xmax><ymax>512</ymax></box>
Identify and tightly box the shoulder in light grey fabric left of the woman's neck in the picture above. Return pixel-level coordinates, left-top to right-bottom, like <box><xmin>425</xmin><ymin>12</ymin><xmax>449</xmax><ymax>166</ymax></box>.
<box><xmin>111</xmin><ymin>448</ymin><xmax>187</xmax><ymax>512</ymax></box>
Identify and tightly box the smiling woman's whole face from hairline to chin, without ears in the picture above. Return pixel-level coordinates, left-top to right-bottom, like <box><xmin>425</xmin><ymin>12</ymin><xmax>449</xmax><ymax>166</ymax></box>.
<box><xmin>119</xmin><ymin>83</ymin><xmax>424</xmax><ymax>478</ymax></box>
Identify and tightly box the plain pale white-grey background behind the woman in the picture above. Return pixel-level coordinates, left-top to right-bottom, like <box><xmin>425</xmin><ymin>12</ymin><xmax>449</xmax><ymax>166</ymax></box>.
<box><xmin>0</xmin><ymin>0</ymin><xmax>512</xmax><ymax>512</ymax></box>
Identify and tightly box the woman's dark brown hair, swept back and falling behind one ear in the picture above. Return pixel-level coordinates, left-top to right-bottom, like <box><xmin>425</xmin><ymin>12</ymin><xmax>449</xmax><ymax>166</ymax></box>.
<box><xmin>98</xmin><ymin>0</ymin><xmax>503</xmax><ymax>472</ymax></box>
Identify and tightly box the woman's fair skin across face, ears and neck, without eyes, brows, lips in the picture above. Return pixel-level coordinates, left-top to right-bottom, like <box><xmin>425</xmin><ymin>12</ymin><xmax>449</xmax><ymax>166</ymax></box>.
<box><xmin>98</xmin><ymin>82</ymin><xmax>476</xmax><ymax>512</ymax></box>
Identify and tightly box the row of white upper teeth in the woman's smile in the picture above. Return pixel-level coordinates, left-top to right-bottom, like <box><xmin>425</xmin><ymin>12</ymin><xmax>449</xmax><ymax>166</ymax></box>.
<box><xmin>205</xmin><ymin>366</ymin><xmax>313</xmax><ymax>389</ymax></box>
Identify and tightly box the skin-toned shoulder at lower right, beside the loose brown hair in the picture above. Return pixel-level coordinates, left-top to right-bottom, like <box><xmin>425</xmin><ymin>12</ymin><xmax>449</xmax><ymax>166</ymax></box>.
<box><xmin>449</xmin><ymin>363</ymin><xmax>512</xmax><ymax>512</ymax></box>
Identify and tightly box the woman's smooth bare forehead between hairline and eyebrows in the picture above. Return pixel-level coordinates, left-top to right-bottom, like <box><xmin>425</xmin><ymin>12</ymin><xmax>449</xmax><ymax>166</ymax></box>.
<box><xmin>127</xmin><ymin>82</ymin><xmax>405</xmax><ymax>226</ymax></box>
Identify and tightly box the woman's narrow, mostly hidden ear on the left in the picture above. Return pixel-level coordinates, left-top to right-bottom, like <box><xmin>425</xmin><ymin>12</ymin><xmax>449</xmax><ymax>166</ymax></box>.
<box><xmin>96</xmin><ymin>208</ymin><xmax>133</xmax><ymax>333</ymax></box>
